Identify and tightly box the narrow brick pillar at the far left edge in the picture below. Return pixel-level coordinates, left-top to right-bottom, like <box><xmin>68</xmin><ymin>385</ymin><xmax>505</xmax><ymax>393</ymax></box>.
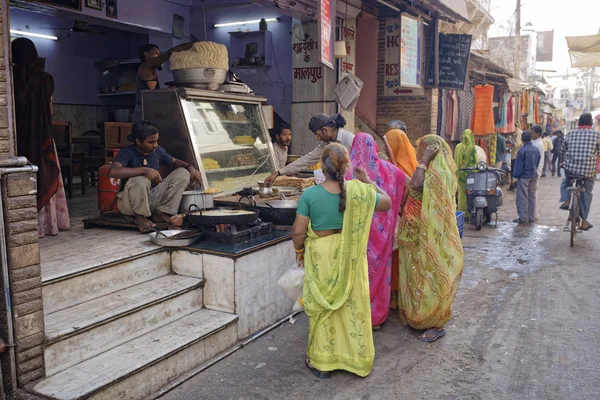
<box><xmin>0</xmin><ymin>1</ymin><xmax>45</xmax><ymax>392</ymax></box>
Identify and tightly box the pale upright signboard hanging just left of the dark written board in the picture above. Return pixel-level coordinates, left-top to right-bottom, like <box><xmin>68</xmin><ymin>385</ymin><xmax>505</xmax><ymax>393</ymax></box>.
<box><xmin>400</xmin><ymin>14</ymin><xmax>423</xmax><ymax>88</ymax></box>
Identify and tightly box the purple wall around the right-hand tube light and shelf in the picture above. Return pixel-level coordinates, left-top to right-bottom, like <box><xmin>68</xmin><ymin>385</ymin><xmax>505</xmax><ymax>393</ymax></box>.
<box><xmin>190</xmin><ymin>0</ymin><xmax>292</xmax><ymax>123</ymax></box>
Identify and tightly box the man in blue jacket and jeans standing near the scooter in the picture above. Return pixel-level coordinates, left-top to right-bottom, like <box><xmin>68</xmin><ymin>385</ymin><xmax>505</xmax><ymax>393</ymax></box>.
<box><xmin>513</xmin><ymin>131</ymin><xmax>541</xmax><ymax>224</ymax></box>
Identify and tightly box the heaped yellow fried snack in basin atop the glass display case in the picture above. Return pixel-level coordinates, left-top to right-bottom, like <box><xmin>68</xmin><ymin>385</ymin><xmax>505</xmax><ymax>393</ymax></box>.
<box><xmin>169</xmin><ymin>42</ymin><xmax>229</xmax><ymax>71</ymax></box>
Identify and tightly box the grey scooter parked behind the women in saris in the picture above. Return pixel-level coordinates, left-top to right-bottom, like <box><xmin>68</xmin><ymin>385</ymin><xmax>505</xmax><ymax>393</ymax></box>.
<box><xmin>462</xmin><ymin>161</ymin><xmax>505</xmax><ymax>231</ymax></box>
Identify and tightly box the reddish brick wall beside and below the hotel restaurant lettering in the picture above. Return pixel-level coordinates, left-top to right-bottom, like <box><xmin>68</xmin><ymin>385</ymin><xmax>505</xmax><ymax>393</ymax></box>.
<box><xmin>377</xmin><ymin>20</ymin><xmax>437</xmax><ymax>142</ymax></box>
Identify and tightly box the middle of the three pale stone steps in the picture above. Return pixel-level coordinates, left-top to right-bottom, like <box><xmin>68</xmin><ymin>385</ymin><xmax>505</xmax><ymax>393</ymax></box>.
<box><xmin>44</xmin><ymin>275</ymin><xmax>204</xmax><ymax>376</ymax></box>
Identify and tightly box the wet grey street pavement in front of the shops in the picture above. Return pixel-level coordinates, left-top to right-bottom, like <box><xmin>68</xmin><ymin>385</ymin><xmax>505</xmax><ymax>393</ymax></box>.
<box><xmin>161</xmin><ymin>177</ymin><xmax>600</xmax><ymax>400</ymax></box>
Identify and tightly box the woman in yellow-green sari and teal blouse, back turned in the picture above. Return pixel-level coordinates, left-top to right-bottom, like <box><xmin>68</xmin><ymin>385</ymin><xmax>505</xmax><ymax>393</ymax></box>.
<box><xmin>292</xmin><ymin>143</ymin><xmax>391</xmax><ymax>379</ymax></box>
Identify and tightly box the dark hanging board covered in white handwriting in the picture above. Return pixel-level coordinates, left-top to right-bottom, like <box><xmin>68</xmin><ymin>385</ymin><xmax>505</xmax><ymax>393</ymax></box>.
<box><xmin>438</xmin><ymin>33</ymin><xmax>471</xmax><ymax>90</ymax></box>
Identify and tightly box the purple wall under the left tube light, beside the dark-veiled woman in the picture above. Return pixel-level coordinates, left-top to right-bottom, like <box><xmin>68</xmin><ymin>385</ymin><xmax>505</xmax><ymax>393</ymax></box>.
<box><xmin>10</xmin><ymin>9</ymin><xmax>148</xmax><ymax>105</ymax></box>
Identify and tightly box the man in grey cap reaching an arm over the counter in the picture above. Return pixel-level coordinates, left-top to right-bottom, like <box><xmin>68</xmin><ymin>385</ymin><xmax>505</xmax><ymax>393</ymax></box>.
<box><xmin>265</xmin><ymin>114</ymin><xmax>354</xmax><ymax>183</ymax></box>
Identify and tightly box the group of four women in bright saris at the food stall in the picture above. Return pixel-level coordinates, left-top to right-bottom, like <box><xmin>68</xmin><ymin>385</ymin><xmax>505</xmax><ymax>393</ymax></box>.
<box><xmin>292</xmin><ymin>115</ymin><xmax>463</xmax><ymax>378</ymax></box>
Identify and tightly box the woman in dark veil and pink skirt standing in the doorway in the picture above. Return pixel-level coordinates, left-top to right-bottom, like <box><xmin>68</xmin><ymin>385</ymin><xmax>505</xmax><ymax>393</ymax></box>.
<box><xmin>12</xmin><ymin>38</ymin><xmax>70</xmax><ymax>237</ymax></box>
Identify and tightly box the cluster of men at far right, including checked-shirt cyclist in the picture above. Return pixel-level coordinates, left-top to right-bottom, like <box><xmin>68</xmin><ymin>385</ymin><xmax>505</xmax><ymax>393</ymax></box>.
<box><xmin>513</xmin><ymin>113</ymin><xmax>600</xmax><ymax>231</ymax></box>
